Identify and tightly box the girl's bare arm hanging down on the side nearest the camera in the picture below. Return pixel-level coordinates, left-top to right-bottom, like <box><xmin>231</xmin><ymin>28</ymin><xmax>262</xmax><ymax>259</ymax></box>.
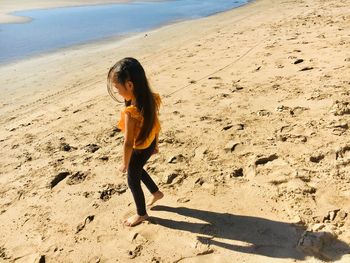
<box><xmin>120</xmin><ymin>113</ymin><xmax>135</xmax><ymax>173</ymax></box>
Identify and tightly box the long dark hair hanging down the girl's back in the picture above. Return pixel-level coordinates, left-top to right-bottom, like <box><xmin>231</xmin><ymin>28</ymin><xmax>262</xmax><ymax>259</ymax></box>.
<box><xmin>107</xmin><ymin>57</ymin><xmax>157</xmax><ymax>142</ymax></box>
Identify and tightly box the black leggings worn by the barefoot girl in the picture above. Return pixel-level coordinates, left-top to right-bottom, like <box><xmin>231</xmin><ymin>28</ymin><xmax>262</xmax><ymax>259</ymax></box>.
<box><xmin>128</xmin><ymin>139</ymin><xmax>158</xmax><ymax>216</ymax></box>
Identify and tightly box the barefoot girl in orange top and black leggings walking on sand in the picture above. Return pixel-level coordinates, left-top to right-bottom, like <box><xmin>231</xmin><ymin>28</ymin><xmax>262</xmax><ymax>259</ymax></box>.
<box><xmin>107</xmin><ymin>58</ymin><xmax>164</xmax><ymax>226</ymax></box>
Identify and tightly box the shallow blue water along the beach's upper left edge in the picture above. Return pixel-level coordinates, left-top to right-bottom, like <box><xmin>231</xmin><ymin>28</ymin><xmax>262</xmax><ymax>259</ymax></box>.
<box><xmin>0</xmin><ymin>0</ymin><xmax>248</xmax><ymax>63</ymax></box>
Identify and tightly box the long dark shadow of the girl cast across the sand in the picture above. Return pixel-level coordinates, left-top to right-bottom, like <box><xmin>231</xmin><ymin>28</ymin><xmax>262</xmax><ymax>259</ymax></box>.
<box><xmin>150</xmin><ymin>205</ymin><xmax>350</xmax><ymax>261</ymax></box>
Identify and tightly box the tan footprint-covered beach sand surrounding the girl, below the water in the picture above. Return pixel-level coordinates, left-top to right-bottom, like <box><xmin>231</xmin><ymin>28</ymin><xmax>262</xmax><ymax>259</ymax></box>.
<box><xmin>0</xmin><ymin>0</ymin><xmax>350</xmax><ymax>263</ymax></box>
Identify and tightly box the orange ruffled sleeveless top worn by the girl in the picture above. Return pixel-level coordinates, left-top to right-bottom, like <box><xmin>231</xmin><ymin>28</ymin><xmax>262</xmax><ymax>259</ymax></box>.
<box><xmin>118</xmin><ymin>93</ymin><xmax>161</xmax><ymax>149</ymax></box>
